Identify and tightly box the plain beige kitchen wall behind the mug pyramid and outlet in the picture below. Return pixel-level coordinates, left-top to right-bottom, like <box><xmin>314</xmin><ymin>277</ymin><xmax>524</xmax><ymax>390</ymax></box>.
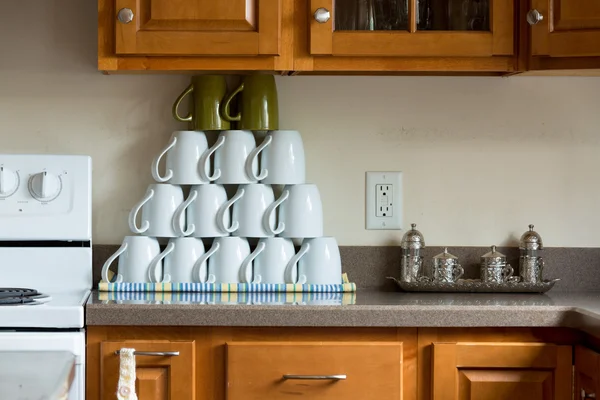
<box><xmin>0</xmin><ymin>0</ymin><xmax>600</xmax><ymax>246</ymax></box>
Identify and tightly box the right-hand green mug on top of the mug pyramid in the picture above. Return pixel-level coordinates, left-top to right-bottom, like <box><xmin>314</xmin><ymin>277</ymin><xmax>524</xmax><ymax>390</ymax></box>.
<box><xmin>221</xmin><ymin>75</ymin><xmax>279</xmax><ymax>131</ymax></box>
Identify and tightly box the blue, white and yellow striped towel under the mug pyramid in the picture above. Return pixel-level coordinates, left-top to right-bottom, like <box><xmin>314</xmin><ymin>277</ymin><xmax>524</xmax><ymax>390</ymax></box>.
<box><xmin>98</xmin><ymin>274</ymin><xmax>356</xmax><ymax>293</ymax></box>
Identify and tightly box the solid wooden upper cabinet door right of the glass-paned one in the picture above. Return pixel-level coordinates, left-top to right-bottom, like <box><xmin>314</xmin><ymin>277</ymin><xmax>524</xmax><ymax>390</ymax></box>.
<box><xmin>527</xmin><ymin>0</ymin><xmax>600</xmax><ymax>57</ymax></box>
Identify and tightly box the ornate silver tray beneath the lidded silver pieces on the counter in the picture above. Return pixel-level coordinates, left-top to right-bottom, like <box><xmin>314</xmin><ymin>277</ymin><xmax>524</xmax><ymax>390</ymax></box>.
<box><xmin>388</xmin><ymin>277</ymin><xmax>560</xmax><ymax>293</ymax></box>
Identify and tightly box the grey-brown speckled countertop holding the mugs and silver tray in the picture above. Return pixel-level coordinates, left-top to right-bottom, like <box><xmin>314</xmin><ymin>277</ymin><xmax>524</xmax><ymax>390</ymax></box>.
<box><xmin>86</xmin><ymin>290</ymin><xmax>600</xmax><ymax>333</ymax></box>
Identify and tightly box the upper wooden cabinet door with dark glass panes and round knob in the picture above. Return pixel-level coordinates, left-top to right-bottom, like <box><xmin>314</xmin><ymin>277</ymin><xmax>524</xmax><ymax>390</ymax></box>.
<box><xmin>309</xmin><ymin>0</ymin><xmax>514</xmax><ymax>57</ymax></box>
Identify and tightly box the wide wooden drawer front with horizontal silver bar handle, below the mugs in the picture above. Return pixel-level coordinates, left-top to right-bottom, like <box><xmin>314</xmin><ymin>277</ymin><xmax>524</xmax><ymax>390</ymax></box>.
<box><xmin>227</xmin><ymin>342</ymin><xmax>402</xmax><ymax>400</ymax></box>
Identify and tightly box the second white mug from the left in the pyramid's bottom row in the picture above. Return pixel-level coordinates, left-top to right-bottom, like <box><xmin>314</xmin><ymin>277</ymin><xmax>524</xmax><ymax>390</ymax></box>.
<box><xmin>150</xmin><ymin>237</ymin><xmax>206</xmax><ymax>283</ymax></box>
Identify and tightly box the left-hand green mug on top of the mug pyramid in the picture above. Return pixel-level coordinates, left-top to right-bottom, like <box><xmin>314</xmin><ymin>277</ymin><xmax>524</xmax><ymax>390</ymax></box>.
<box><xmin>173</xmin><ymin>75</ymin><xmax>231</xmax><ymax>131</ymax></box>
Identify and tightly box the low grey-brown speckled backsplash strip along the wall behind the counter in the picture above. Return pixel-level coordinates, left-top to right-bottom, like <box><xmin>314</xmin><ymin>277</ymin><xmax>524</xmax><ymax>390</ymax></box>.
<box><xmin>93</xmin><ymin>245</ymin><xmax>600</xmax><ymax>291</ymax></box>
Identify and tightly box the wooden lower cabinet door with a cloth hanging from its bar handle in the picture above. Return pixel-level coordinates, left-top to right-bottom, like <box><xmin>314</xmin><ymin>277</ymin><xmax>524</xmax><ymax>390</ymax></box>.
<box><xmin>100</xmin><ymin>340</ymin><xmax>195</xmax><ymax>400</ymax></box>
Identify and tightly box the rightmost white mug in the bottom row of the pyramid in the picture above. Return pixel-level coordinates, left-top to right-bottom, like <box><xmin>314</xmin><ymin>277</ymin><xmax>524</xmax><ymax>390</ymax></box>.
<box><xmin>285</xmin><ymin>237</ymin><xmax>342</xmax><ymax>285</ymax></box>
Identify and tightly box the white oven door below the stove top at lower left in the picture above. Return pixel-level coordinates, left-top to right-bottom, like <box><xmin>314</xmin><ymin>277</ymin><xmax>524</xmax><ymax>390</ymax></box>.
<box><xmin>0</xmin><ymin>331</ymin><xmax>85</xmax><ymax>400</ymax></box>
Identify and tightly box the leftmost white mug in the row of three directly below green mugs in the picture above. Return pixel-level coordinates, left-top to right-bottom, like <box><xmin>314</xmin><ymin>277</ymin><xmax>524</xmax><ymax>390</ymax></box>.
<box><xmin>152</xmin><ymin>131</ymin><xmax>210</xmax><ymax>185</ymax></box>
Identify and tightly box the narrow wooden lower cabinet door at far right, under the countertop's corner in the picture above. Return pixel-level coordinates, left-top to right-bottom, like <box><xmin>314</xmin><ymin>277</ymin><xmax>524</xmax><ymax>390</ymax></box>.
<box><xmin>575</xmin><ymin>346</ymin><xmax>600</xmax><ymax>400</ymax></box>
